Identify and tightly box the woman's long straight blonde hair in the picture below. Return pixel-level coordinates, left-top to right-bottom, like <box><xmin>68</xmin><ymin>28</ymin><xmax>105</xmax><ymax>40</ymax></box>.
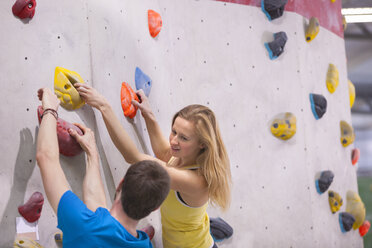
<box><xmin>172</xmin><ymin>104</ymin><xmax>231</xmax><ymax>210</ymax></box>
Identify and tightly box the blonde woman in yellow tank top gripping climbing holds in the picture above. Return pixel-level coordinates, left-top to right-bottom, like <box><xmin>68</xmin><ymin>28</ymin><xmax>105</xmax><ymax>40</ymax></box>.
<box><xmin>74</xmin><ymin>84</ymin><xmax>231</xmax><ymax>248</ymax></box>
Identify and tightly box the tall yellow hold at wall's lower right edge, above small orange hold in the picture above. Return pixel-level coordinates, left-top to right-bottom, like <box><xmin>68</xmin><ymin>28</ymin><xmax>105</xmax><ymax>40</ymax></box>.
<box><xmin>346</xmin><ymin>190</ymin><xmax>366</xmax><ymax>230</ymax></box>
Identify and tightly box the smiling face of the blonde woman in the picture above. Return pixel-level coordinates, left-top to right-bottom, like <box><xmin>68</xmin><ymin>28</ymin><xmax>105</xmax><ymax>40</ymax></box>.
<box><xmin>169</xmin><ymin>117</ymin><xmax>202</xmax><ymax>162</ymax></box>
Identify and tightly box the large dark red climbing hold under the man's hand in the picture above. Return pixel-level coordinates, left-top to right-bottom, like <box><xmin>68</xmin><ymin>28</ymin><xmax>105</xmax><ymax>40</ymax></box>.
<box><xmin>37</xmin><ymin>106</ymin><xmax>83</xmax><ymax>157</ymax></box>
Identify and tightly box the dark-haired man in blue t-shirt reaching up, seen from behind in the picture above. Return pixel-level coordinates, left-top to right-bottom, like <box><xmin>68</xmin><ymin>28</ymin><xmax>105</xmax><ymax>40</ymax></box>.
<box><xmin>36</xmin><ymin>88</ymin><xmax>170</xmax><ymax>248</ymax></box>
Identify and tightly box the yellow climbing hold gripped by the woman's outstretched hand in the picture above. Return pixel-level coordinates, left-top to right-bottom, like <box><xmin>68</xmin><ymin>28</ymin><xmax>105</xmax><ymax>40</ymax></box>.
<box><xmin>54</xmin><ymin>67</ymin><xmax>85</xmax><ymax>110</ymax></box>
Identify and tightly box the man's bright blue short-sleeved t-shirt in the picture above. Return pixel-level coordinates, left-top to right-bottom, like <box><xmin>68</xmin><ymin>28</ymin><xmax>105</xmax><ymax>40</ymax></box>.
<box><xmin>57</xmin><ymin>190</ymin><xmax>152</xmax><ymax>248</ymax></box>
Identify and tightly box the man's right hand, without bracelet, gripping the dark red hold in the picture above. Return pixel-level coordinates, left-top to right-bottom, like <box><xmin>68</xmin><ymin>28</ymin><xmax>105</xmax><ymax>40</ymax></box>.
<box><xmin>68</xmin><ymin>123</ymin><xmax>97</xmax><ymax>155</ymax></box>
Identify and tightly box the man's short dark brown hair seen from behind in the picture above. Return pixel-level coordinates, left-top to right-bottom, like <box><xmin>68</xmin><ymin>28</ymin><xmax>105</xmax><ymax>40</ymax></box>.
<box><xmin>121</xmin><ymin>160</ymin><xmax>170</xmax><ymax>220</ymax></box>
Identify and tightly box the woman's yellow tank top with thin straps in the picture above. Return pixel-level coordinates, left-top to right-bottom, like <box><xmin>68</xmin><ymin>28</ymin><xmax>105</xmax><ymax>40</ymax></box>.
<box><xmin>160</xmin><ymin>158</ymin><xmax>213</xmax><ymax>248</ymax></box>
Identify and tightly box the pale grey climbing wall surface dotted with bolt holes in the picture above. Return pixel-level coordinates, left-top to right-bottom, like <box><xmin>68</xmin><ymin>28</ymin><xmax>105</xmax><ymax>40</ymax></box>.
<box><xmin>0</xmin><ymin>0</ymin><xmax>363</xmax><ymax>248</ymax></box>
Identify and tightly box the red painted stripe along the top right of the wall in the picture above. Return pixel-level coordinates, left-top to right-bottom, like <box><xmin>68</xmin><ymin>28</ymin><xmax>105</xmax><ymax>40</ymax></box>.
<box><xmin>215</xmin><ymin>0</ymin><xmax>344</xmax><ymax>38</ymax></box>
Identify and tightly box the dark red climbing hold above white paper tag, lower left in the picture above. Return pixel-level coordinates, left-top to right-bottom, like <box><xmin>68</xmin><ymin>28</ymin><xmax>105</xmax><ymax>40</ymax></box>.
<box><xmin>18</xmin><ymin>192</ymin><xmax>44</xmax><ymax>222</ymax></box>
